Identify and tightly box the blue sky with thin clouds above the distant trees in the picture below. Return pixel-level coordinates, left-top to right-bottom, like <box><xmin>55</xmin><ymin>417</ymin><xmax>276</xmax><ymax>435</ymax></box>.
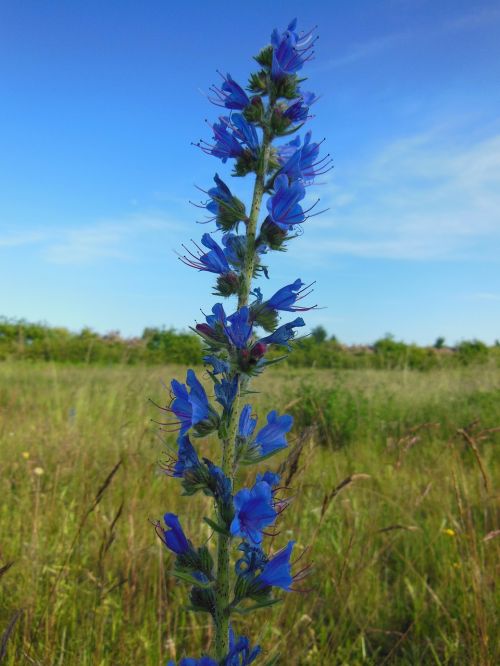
<box><xmin>0</xmin><ymin>0</ymin><xmax>500</xmax><ymax>343</ymax></box>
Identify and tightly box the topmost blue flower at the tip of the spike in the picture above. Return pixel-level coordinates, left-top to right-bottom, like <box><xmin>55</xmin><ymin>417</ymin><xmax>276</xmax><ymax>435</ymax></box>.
<box><xmin>271</xmin><ymin>19</ymin><xmax>314</xmax><ymax>81</ymax></box>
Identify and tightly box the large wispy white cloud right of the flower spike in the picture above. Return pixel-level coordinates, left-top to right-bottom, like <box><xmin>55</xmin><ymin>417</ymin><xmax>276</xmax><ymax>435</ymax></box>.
<box><xmin>292</xmin><ymin>128</ymin><xmax>500</xmax><ymax>261</ymax></box>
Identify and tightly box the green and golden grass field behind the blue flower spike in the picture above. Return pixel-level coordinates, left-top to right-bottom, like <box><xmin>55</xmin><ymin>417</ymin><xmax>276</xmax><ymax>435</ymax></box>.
<box><xmin>0</xmin><ymin>362</ymin><xmax>500</xmax><ymax>666</ymax></box>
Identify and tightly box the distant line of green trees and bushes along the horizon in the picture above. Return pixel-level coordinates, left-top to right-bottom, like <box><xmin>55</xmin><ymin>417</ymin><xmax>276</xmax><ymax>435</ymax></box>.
<box><xmin>0</xmin><ymin>318</ymin><xmax>500</xmax><ymax>370</ymax></box>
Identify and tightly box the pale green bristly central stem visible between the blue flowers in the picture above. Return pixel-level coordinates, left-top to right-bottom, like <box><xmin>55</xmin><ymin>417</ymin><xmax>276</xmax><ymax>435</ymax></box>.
<box><xmin>214</xmin><ymin>120</ymin><xmax>272</xmax><ymax>661</ymax></box>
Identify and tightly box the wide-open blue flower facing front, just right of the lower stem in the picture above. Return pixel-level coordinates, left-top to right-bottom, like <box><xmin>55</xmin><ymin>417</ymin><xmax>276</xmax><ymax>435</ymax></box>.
<box><xmin>231</xmin><ymin>481</ymin><xmax>277</xmax><ymax>544</ymax></box>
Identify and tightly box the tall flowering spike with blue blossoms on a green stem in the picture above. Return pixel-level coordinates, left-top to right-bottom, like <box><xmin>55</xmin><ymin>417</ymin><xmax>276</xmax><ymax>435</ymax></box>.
<box><xmin>156</xmin><ymin>20</ymin><xmax>330</xmax><ymax>666</ymax></box>
